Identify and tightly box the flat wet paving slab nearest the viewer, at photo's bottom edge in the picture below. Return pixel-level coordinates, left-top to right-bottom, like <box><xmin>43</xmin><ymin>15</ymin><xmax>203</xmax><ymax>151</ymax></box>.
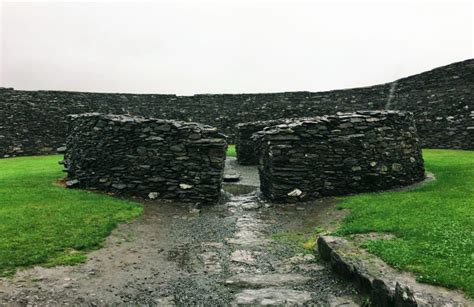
<box><xmin>234</xmin><ymin>288</ymin><xmax>311</xmax><ymax>306</ymax></box>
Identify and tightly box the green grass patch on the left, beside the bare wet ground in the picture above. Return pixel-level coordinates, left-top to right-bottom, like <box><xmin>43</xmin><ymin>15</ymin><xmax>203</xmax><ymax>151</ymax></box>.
<box><xmin>0</xmin><ymin>156</ymin><xmax>142</xmax><ymax>276</ymax></box>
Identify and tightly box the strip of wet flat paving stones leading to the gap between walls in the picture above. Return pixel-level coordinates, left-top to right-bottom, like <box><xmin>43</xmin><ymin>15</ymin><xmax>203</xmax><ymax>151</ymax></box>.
<box><xmin>220</xmin><ymin>194</ymin><xmax>355</xmax><ymax>305</ymax></box>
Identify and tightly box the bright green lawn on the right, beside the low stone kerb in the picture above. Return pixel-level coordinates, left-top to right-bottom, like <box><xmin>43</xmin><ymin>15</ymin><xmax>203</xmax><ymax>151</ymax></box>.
<box><xmin>338</xmin><ymin>150</ymin><xmax>474</xmax><ymax>297</ymax></box>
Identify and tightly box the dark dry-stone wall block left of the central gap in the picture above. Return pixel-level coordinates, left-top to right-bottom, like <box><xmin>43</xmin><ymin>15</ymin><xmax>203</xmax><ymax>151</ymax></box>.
<box><xmin>63</xmin><ymin>113</ymin><xmax>227</xmax><ymax>203</ymax></box>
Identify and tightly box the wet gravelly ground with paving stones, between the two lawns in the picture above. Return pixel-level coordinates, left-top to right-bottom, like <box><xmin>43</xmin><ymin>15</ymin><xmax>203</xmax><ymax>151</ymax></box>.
<box><xmin>0</xmin><ymin>161</ymin><xmax>361</xmax><ymax>306</ymax></box>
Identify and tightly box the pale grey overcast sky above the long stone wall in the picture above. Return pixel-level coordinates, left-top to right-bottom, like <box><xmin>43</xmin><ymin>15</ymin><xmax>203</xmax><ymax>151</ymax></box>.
<box><xmin>0</xmin><ymin>0</ymin><xmax>474</xmax><ymax>95</ymax></box>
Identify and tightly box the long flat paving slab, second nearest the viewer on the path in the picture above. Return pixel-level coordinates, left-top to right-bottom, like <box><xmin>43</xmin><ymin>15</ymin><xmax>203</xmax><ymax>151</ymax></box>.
<box><xmin>225</xmin><ymin>273</ymin><xmax>310</xmax><ymax>288</ymax></box>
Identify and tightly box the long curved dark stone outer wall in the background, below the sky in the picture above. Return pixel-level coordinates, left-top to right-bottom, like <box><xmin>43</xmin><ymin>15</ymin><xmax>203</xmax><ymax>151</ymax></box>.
<box><xmin>0</xmin><ymin>59</ymin><xmax>474</xmax><ymax>157</ymax></box>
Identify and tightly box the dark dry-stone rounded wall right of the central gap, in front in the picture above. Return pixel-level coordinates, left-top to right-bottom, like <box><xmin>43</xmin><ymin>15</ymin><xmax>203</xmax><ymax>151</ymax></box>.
<box><xmin>255</xmin><ymin>111</ymin><xmax>424</xmax><ymax>202</ymax></box>
